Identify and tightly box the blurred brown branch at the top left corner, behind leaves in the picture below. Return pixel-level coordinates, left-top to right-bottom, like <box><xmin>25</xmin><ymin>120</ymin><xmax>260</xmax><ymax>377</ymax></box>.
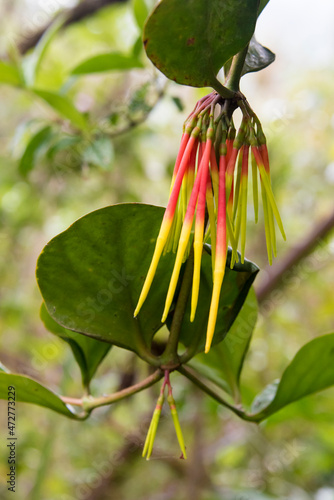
<box><xmin>18</xmin><ymin>0</ymin><xmax>126</xmax><ymax>54</ymax></box>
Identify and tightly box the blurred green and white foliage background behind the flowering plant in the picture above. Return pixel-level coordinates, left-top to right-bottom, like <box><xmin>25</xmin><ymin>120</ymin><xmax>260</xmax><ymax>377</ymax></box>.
<box><xmin>0</xmin><ymin>0</ymin><xmax>334</xmax><ymax>500</ymax></box>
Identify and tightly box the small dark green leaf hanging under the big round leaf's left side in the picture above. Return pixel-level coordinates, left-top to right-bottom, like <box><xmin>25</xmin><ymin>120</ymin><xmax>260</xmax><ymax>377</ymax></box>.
<box><xmin>40</xmin><ymin>304</ymin><xmax>111</xmax><ymax>387</ymax></box>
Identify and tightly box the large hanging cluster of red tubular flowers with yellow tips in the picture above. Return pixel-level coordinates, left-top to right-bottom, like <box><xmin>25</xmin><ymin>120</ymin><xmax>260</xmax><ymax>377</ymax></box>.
<box><xmin>134</xmin><ymin>92</ymin><xmax>285</xmax><ymax>352</ymax></box>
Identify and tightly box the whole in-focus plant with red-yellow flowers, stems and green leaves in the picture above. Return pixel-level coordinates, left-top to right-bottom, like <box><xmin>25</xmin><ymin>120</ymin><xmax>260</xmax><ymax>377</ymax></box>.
<box><xmin>0</xmin><ymin>0</ymin><xmax>334</xmax><ymax>459</ymax></box>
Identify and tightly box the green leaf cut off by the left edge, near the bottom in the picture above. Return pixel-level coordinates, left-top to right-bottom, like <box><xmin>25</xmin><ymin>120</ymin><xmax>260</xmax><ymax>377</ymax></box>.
<box><xmin>0</xmin><ymin>372</ymin><xmax>83</xmax><ymax>419</ymax></box>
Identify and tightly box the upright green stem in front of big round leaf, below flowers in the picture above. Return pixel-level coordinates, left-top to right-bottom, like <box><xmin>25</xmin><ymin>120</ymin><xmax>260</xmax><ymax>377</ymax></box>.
<box><xmin>160</xmin><ymin>247</ymin><xmax>194</xmax><ymax>369</ymax></box>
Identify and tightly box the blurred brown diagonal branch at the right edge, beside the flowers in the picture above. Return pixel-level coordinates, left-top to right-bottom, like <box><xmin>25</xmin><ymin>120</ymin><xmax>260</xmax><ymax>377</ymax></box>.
<box><xmin>255</xmin><ymin>211</ymin><xmax>334</xmax><ymax>304</ymax></box>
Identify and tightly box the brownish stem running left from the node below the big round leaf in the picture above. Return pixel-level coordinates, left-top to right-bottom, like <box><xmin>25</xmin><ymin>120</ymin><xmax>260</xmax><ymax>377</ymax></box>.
<box><xmin>61</xmin><ymin>369</ymin><xmax>164</xmax><ymax>412</ymax></box>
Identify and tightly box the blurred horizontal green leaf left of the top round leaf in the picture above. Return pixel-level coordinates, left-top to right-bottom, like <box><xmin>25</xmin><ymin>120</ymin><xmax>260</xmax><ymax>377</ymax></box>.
<box><xmin>71</xmin><ymin>52</ymin><xmax>143</xmax><ymax>75</ymax></box>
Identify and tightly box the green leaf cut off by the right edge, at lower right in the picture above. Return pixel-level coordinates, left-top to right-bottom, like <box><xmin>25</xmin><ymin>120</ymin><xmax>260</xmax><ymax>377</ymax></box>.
<box><xmin>252</xmin><ymin>333</ymin><xmax>334</xmax><ymax>421</ymax></box>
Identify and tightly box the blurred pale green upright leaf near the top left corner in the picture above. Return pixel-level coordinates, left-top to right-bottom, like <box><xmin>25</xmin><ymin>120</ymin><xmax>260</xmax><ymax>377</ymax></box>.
<box><xmin>22</xmin><ymin>16</ymin><xmax>65</xmax><ymax>87</ymax></box>
